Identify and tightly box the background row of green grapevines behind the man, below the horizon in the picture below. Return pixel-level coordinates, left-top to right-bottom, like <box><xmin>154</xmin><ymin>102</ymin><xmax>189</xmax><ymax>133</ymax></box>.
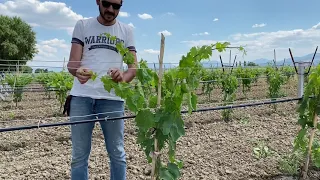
<box><xmin>0</xmin><ymin>66</ymin><xmax>295</xmax><ymax>107</ymax></box>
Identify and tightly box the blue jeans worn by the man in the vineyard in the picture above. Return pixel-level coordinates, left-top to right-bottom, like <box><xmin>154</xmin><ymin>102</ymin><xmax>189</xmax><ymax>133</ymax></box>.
<box><xmin>70</xmin><ymin>96</ymin><xmax>126</xmax><ymax>180</ymax></box>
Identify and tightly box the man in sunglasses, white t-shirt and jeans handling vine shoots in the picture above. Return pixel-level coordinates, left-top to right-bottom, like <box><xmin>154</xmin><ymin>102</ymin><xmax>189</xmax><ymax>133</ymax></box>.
<box><xmin>68</xmin><ymin>0</ymin><xmax>137</xmax><ymax>180</ymax></box>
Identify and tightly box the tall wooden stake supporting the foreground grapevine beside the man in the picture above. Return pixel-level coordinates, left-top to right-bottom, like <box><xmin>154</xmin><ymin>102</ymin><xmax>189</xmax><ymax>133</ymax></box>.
<box><xmin>151</xmin><ymin>33</ymin><xmax>165</xmax><ymax>180</ymax></box>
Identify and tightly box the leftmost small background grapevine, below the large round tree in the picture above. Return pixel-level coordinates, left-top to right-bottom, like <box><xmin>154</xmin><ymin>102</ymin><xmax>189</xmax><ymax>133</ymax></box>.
<box><xmin>4</xmin><ymin>73</ymin><xmax>33</xmax><ymax>106</ymax></box>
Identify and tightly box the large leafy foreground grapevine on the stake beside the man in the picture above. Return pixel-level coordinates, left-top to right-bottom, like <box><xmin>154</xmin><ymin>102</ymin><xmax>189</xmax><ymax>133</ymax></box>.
<box><xmin>92</xmin><ymin>34</ymin><xmax>245</xmax><ymax>180</ymax></box>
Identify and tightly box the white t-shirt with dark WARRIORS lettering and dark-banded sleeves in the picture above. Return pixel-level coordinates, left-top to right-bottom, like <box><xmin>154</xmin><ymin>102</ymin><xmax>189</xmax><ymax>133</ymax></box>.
<box><xmin>70</xmin><ymin>18</ymin><xmax>136</xmax><ymax>101</ymax></box>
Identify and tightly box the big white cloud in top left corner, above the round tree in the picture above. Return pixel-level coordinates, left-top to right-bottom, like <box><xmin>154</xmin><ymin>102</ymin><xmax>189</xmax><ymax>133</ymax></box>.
<box><xmin>0</xmin><ymin>0</ymin><xmax>84</xmax><ymax>34</ymax></box>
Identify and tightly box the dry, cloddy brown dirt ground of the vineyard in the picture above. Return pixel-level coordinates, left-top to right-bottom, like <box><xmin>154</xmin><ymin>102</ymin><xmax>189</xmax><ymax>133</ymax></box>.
<box><xmin>0</xmin><ymin>77</ymin><xmax>320</xmax><ymax>180</ymax></box>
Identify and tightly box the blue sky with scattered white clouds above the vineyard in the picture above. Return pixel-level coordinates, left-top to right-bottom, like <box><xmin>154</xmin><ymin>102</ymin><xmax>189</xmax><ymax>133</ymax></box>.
<box><xmin>0</xmin><ymin>0</ymin><xmax>320</xmax><ymax>70</ymax></box>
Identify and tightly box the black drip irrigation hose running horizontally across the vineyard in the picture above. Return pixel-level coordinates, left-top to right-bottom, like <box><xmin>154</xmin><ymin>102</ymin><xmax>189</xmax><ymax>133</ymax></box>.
<box><xmin>0</xmin><ymin>98</ymin><xmax>302</xmax><ymax>133</ymax></box>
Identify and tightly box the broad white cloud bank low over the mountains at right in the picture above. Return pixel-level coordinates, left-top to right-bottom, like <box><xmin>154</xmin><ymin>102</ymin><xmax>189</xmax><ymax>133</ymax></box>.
<box><xmin>182</xmin><ymin>23</ymin><xmax>320</xmax><ymax>60</ymax></box>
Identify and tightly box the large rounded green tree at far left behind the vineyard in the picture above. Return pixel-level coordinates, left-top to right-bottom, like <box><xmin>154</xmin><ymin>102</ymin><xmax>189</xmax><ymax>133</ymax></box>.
<box><xmin>0</xmin><ymin>15</ymin><xmax>38</xmax><ymax>71</ymax></box>
